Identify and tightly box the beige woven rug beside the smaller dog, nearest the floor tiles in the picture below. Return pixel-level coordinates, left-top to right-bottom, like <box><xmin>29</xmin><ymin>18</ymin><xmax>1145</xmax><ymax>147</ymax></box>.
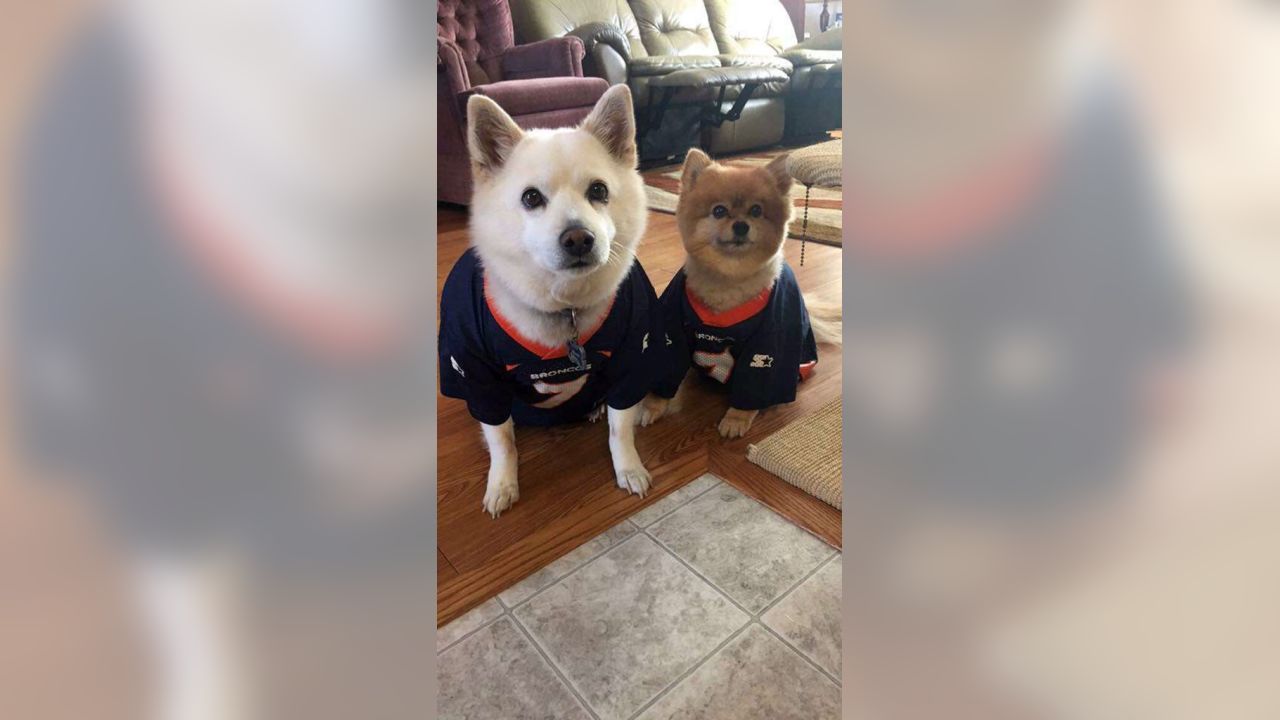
<box><xmin>746</xmin><ymin>398</ymin><xmax>844</xmax><ymax>510</ymax></box>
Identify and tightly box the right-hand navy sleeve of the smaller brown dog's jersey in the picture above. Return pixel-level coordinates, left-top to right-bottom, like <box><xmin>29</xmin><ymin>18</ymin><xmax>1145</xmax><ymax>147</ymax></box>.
<box><xmin>730</xmin><ymin>266</ymin><xmax>817</xmax><ymax>410</ymax></box>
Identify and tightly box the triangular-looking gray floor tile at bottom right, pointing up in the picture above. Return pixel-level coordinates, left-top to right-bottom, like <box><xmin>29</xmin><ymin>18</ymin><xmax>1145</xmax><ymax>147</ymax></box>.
<box><xmin>640</xmin><ymin>624</ymin><xmax>840</xmax><ymax>720</ymax></box>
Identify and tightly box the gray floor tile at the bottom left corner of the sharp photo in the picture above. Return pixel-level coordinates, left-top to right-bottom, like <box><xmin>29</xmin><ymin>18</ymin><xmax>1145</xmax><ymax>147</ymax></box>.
<box><xmin>436</xmin><ymin>618</ymin><xmax>590</xmax><ymax>720</ymax></box>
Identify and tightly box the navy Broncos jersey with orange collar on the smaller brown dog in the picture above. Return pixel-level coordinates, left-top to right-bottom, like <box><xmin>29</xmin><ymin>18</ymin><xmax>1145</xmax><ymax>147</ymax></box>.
<box><xmin>654</xmin><ymin>263</ymin><xmax>818</xmax><ymax>410</ymax></box>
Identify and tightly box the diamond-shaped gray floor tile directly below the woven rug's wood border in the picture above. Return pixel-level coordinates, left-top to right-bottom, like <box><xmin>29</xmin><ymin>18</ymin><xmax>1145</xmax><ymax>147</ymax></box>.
<box><xmin>649</xmin><ymin>484</ymin><xmax>836</xmax><ymax>612</ymax></box>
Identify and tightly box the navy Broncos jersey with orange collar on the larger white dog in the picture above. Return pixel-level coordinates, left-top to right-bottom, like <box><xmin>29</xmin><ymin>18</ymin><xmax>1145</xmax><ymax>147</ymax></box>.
<box><xmin>439</xmin><ymin>250</ymin><xmax>668</xmax><ymax>425</ymax></box>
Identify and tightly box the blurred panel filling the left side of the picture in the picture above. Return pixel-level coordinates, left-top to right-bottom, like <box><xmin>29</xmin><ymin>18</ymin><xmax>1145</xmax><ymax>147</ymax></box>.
<box><xmin>0</xmin><ymin>0</ymin><xmax>435</xmax><ymax>719</ymax></box>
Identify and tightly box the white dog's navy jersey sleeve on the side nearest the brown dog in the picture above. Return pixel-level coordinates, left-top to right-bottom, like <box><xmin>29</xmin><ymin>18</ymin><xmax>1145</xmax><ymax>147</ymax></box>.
<box><xmin>604</xmin><ymin>261</ymin><xmax>669</xmax><ymax>410</ymax></box>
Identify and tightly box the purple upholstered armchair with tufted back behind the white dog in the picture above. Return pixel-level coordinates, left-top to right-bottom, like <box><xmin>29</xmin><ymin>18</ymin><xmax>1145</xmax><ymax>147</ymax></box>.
<box><xmin>435</xmin><ymin>0</ymin><xmax>609</xmax><ymax>205</ymax></box>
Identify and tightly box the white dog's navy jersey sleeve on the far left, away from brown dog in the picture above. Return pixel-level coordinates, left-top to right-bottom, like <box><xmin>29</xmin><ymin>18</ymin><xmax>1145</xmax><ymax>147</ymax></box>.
<box><xmin>439</xmin><ymin>258</ymin><xmax>512</xmax><ymax>425</ymax></box>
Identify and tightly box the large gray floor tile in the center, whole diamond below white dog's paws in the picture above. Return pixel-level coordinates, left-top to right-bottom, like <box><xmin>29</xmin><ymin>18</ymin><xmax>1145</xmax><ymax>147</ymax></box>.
<box><xmin>515</xmin><ymin>536</ymin><xmax>749</xmax><ymax>720</ymax></box>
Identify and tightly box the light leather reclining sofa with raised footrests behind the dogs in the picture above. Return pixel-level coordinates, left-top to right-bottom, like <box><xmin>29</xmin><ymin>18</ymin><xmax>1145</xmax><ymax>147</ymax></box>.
<box><xmin>511</xmin><ymin>0</ymin><xmax>841</xmax><ymax>152</ymax></box>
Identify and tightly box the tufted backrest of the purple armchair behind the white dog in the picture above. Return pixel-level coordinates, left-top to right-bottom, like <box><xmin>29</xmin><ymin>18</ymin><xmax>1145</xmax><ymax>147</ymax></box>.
<box><xmin>435</xmin><ymin>0</ymin><xmax>516</xmax><ymax>85</ymax></box>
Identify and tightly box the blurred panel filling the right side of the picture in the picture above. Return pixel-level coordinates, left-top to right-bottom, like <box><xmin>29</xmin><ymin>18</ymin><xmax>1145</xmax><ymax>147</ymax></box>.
<box><xmin>844</xmin><ymin>0</ymin><xmax>1280</xmax><ymax>719</ymax></box>
